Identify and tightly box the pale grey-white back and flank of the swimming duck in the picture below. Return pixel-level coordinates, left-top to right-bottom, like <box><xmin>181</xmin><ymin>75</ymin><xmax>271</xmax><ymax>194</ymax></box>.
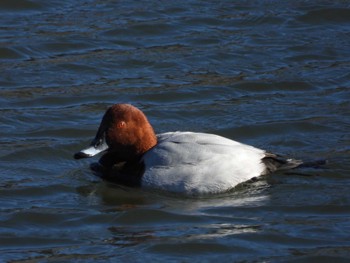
<box><xmin>142</xmin><ymin>132</ymin><xmax>266</xmax><ymax>194</ymax></box>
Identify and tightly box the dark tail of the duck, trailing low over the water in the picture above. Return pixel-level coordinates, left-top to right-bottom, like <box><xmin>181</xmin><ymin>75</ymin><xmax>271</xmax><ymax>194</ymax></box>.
<box><xmin>262</xmin><ymin>153</ymin><xmax>327</xmax><ymax>174</ymax></box>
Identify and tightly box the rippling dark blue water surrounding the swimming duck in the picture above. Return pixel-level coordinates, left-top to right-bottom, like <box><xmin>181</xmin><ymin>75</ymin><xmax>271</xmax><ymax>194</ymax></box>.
<box><xmin>0</xmin><ymin>0</ymin><xmax>350</xmax><ymax>262</ymax></box>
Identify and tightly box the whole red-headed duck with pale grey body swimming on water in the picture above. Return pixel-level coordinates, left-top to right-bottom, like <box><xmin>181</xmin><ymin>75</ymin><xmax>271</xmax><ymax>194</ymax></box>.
<box><xmin>74</xmin><ymin>104</ymin><xmax>303</xmax><ymax>195</ymax></box>
